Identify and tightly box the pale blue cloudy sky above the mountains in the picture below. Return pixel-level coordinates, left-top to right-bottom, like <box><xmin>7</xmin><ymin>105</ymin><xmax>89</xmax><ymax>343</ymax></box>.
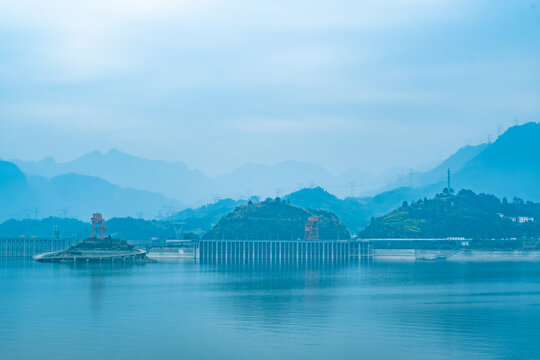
<box><xmin>0</xmin><ymin>0</ymin><xmax>540</xmax><ymax>175</ymax></box>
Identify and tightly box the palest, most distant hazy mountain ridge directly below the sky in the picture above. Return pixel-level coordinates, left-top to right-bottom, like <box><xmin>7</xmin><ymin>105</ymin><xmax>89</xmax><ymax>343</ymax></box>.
<box><xmin>11</xmin><ymin>150</ymin><xmax>394</xmax><ymax>206</ymax></box>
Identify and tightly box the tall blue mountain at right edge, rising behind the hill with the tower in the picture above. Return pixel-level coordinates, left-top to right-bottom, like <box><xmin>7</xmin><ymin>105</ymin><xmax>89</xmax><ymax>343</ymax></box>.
<box><xmin>372</xmin><ymin>122</ymin><xmax>540</xmax><ymax>201</ymax></box>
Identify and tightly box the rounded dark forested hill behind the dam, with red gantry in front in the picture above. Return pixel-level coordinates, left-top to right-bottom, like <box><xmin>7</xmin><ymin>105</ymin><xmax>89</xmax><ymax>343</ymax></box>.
<box><xmin>204</xmin><ymin>198</ymin><xmax>350</xmax><ymax>240</ymax></box>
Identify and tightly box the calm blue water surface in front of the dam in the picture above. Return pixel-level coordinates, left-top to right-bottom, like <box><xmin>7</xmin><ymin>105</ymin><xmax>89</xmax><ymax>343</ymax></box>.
<box><xmin>0</xmin><ymin>259</ymin><xmax>540</xmax><ymax>360</ymax></box>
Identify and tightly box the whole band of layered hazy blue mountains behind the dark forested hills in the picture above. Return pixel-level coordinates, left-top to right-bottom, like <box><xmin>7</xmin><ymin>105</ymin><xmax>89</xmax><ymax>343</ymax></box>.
<box><xmin>0</xmin><ymin>123</ymin><xmax>540</xmax><ymax>228</ymax></box>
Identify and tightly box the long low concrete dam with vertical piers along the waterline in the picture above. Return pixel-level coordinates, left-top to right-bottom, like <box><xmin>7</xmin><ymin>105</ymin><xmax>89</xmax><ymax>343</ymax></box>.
<box><xmin>4</xmin><ymin>237</ymin><xmax>540</xmax><ymax>263</ymax></box>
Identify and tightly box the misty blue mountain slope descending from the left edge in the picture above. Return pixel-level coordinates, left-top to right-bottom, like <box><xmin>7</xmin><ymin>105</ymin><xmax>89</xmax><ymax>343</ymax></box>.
<box><xmin>0</xmin><ymin>161</ymin><xmax>181</xmax><ymax>220</ymax></box>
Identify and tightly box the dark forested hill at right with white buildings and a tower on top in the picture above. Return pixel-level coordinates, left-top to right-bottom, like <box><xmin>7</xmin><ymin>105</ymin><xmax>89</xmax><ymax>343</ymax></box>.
<box><xmin>359</xmin><ymin>190</ymin><xmax>540</xmax><ymax>239</ymax></box>
